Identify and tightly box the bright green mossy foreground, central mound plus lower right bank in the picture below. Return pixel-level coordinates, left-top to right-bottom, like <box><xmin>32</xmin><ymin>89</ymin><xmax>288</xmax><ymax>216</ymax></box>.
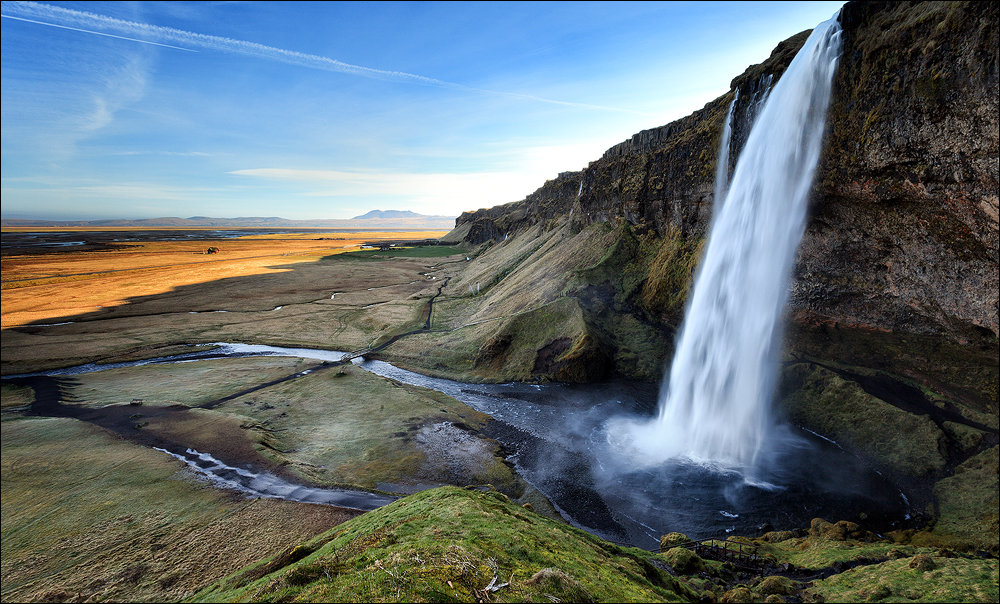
<box><xmin>188</xmin><ymin>487</ymin><xmax>998</xmax><ymax>602</ymax></box>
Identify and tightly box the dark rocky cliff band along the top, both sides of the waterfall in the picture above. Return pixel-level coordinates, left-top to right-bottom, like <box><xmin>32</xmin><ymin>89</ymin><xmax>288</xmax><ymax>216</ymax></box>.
<box><xmin>458</xmin><ymin>2</ymin><xmax>1000</xmax><ymax>343</ymax></box>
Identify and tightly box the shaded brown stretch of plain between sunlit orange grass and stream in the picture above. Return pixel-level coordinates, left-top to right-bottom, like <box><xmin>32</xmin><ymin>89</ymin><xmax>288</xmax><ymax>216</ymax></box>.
<box><xmin>0</xmin><ymin>246</ymin><xmax>476</xmax><ymax>382</ymax></box>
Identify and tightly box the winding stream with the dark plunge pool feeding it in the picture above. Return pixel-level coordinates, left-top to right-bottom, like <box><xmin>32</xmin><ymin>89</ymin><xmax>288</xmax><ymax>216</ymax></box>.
<box><xmin>3</xmin><ymin>343</ymin><xmax>909</xmax><ymax>549</ymax></box>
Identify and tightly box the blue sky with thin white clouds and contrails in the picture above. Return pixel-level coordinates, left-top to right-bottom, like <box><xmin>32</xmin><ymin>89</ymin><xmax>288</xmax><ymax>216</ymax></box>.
<box><xmin>0</xmin><ymin>2</ymin><xmax>843</xmax><ymax>220</ymax></box>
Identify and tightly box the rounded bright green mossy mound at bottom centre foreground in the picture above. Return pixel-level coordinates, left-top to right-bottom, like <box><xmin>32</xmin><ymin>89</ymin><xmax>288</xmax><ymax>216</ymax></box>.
<box><xmin>191</xmin><ymin>487</ymin><xmax>700</xmax><ymax>602</ymax></box>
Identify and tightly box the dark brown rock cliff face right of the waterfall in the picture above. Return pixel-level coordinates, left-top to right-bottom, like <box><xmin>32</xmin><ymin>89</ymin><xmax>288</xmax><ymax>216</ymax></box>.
<box><xmin>792</xmin><ymin>3</ymin><xmax>1000</xmax><ymax>341</ymax></box>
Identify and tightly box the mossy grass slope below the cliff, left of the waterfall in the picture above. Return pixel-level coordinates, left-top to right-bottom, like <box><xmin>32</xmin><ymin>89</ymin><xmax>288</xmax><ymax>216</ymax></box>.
<box><xmin>380</xmin><ymin>221</ymin><xmax>700</xmax><ymax>382</ymax></box>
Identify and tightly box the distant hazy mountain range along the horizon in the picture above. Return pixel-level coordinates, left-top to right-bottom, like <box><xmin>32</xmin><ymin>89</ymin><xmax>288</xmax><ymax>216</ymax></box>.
<box><xmin>0</xmin><ymin>210</ymin><xmax>455</xmax><ymax>230</ymax></box>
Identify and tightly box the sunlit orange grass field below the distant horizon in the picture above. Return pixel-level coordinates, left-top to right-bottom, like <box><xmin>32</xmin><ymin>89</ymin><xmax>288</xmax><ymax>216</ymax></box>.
<box><xmin>0</xmin><ymin>227</ymin><xmax>446</xmax><ymax>328</ymax></box>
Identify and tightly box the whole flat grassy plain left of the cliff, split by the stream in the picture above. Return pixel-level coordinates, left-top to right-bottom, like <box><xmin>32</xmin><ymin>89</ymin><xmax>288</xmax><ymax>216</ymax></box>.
<box><xmin>0</xmin><ymin>229</ymin><xmax>537</xmax><ymax>601</ymax></box>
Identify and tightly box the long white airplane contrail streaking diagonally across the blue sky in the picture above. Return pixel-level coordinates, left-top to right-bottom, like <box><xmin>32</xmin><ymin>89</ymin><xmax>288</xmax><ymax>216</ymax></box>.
<box><xmin>2</xmin><ymin>1</ymin><xmax>644</xmax><ymax>114</ymax></box>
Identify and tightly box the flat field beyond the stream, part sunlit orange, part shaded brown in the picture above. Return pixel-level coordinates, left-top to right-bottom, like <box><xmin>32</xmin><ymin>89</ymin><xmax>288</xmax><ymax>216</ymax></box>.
<box><xmin>0</xmin><ymin>229</ymin><xmax>464</xmax><ymax>374</ymax></box>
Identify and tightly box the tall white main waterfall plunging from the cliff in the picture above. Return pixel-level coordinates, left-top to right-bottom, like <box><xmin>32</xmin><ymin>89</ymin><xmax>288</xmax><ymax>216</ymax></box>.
<box><xmin>609</xmin><ymin>16</ymin><xmax>840</xmax><ymax>473</ymax></box>
